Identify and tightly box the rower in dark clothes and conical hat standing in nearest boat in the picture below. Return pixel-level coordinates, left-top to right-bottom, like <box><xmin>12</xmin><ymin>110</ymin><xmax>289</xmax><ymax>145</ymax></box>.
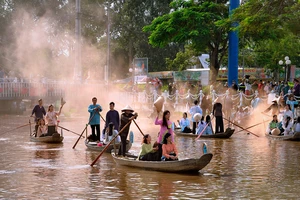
<box><xmin>118</xmin><ymin>105</ymin><xmax>138</xmax><ymax>157</ymax></box>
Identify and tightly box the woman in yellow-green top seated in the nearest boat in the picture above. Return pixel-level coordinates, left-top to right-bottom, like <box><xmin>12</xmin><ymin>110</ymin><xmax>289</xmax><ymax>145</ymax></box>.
<box><xmin>138</xmin><ymin>134</ymin><xmax>160</xmax><ymax>161</ymax></box>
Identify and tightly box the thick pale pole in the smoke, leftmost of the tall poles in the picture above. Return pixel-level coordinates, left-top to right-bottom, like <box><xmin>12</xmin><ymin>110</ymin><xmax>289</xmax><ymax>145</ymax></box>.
<box><xmin>74</xmin><ymin>0</ymin><xmax>82</xmax><ymax>81</ymax></box>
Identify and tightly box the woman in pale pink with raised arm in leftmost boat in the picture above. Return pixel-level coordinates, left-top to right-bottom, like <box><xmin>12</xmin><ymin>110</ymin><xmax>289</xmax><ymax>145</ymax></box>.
<box><xmin>46</xmin><ymin>104</ymin><xmax>63</xmax><ymax>135</ymax></box>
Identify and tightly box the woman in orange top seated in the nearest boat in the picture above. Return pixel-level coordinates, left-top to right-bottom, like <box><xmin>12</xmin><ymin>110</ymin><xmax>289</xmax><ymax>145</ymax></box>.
<box><xmin>161</xmin><ymin>133</ymin><xmax>178</xmax><ymax>161</ymax></box>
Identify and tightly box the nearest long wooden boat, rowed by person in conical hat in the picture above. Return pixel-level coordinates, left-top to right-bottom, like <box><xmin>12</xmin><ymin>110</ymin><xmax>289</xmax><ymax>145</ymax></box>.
<box><xmin>111</xmin><ymin>152</ymin><xmax>213</xmax><ymax>173</ymax></box>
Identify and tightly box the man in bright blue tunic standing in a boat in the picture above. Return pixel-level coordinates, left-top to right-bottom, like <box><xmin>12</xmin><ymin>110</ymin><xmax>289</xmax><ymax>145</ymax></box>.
<box><xmin>88</xmin><ymin>97</ymin><xmax>102</xmax><ymax>142</ymax></box>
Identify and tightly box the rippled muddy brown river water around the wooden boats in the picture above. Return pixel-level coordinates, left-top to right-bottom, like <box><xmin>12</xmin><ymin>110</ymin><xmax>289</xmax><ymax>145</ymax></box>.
<box><xmin>0</xmin><ymin>115</ymin><xmax>300</xmax><ymax>199</ymax></box>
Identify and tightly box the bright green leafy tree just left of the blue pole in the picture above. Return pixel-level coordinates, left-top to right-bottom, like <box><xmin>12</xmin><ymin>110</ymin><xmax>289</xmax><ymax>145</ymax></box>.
<box><xmin>144</xmin><ymin>0</ymin><xmax>230</xmax><ymax>81</ymax></box>
